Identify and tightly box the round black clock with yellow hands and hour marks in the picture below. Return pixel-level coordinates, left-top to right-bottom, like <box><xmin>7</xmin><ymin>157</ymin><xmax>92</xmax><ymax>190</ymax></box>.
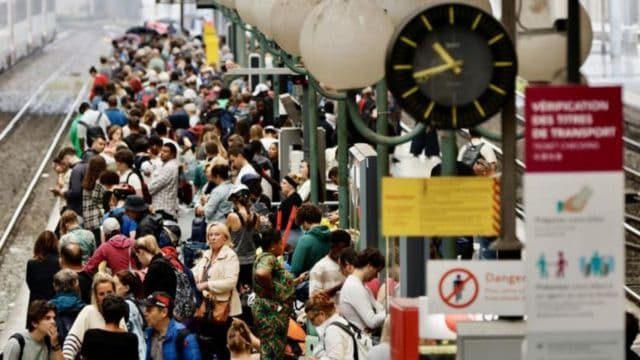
<box><xmin>386</xmin><ymin>4</ymin><xmax>518</xmax><ymax>129</ymax></box>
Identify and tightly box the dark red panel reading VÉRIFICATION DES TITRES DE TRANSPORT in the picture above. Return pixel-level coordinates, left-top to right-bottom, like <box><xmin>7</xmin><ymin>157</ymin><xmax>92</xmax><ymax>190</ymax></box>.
<box><xmin>525</xmin><ymin>86</ymin><xmax>623</xmax><ymax>172</ymax></box>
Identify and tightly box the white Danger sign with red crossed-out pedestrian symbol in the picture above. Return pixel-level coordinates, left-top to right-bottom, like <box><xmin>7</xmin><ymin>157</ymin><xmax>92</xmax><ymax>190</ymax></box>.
<box><xmin>427</xmin><ymin>260</ymin><xmax>525</xmax><ymax>315</ymax></box>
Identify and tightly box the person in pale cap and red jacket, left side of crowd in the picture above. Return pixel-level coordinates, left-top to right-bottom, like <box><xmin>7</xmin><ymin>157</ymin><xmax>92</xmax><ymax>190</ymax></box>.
<box><xmin>84</xmin><ymin>218</ymin><xmax>135</xmax><ymax>274</ymax></box>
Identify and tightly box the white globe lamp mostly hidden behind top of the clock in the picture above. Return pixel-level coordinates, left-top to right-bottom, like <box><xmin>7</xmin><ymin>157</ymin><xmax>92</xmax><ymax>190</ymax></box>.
<box><xmin>375</xmin><ymin>0</ymin><xmax>492</xmax><ymax>27</ymax></box>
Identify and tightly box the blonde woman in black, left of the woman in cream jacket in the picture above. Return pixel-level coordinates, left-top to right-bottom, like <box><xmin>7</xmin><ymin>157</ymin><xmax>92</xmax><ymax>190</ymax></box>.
<box><xmin>135</xmin><ymin>235</ymin><xmax>177</xmax><ymax>299</ymax></box>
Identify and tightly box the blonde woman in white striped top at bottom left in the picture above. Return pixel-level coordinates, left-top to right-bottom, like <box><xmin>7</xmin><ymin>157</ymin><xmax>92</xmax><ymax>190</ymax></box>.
<box><xmin>62</xmin><ymin>273</ymin><xmax>126</xmax><ymax>359</ymax></box>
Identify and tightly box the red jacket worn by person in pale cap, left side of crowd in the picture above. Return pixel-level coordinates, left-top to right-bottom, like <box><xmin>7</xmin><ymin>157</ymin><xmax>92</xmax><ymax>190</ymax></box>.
<box><xmin>84</xmin><ymin>234</ymin><xmax>135</xmax><ymax>275</ymax></box>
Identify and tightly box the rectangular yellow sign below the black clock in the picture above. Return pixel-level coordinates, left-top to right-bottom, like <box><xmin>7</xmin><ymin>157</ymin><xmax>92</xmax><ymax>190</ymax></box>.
<box><xmin>382</xmin><ymin>177</ymin><xmax>499</xmax><ymax>236</ymax></box>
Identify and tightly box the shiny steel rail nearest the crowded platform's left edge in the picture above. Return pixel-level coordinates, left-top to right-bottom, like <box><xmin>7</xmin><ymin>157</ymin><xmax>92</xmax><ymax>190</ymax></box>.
<box><xmin>0</xmin><ymin>80</ymin><xmax>90</xmax><ymax>251</ymax></box>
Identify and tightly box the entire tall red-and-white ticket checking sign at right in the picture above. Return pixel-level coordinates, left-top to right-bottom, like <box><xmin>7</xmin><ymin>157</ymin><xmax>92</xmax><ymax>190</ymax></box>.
<box><xmin>524</xmin><ymin>86</ymin><xmax>625</xmax><ymax>360</ymax></box>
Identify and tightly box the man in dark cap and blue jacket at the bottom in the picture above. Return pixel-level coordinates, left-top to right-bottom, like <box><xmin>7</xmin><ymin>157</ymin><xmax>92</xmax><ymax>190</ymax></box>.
<box><xmin>144</xmin><ymin>291</ymin><xmax>201</xmax><ymax>360</ymax></box>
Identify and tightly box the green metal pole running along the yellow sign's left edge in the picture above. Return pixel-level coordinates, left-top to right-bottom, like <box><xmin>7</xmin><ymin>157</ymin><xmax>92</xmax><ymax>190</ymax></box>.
<box><xmin>376</xmin><ymin>79</ymin><xmax>389</xmax><ymax>252</ymax></box>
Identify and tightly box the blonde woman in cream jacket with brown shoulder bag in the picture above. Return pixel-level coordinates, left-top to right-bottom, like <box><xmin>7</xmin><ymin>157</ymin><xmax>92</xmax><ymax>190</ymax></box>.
<box><xmin>193</xmin><ymin>222</ymin><xmax>242</xmax><ymax>359</ymax></box>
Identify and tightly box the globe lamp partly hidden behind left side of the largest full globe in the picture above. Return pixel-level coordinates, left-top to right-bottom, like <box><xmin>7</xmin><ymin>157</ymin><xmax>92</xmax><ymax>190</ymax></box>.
<box><xmin>270</xmin><ymin>0</ymin><xmax>322</xmax><ymax>56</ymax></box>
